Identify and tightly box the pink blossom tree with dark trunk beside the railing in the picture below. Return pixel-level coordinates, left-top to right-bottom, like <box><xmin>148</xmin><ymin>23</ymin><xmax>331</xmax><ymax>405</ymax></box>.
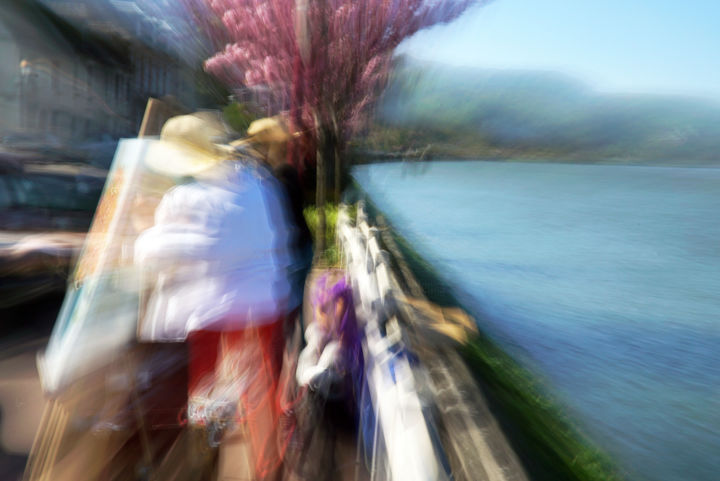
<box><xmin>185</xmin><ymin>0</ymin><xmax>486</xmax><ymax>252</ymax></box>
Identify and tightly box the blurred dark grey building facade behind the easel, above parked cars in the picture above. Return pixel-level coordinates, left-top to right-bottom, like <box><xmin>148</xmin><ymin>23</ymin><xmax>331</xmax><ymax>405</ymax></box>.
<box><xmin>0</xmin><ymin>0</ymin><xmax>196</xmax><ymax>144</ymax></box>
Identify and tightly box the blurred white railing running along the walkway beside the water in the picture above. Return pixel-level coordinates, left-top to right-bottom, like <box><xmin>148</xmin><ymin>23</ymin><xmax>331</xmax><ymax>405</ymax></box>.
<box><xmin>336</xmin><ymin>203</ymin><xmax>449</xmax><ymax>481</ymax></box>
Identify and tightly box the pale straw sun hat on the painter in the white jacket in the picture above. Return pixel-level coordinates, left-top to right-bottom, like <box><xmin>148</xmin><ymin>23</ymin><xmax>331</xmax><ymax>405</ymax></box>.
<box><xmin>145</xmin><ymin>112</ymin><xmax>234</xmax><ymax>177</ymax></box>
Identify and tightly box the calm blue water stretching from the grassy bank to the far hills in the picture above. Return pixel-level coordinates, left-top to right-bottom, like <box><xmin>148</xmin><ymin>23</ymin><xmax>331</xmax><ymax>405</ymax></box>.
<box><xmin>353</xmin><ymin>162</ymin><xmax>720</xmax><ymax>481</ymax></box>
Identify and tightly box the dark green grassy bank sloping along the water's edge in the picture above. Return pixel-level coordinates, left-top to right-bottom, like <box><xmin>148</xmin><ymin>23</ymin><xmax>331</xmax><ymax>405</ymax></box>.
<box><xmin>354</xmin><ymin>185</ymin><xmax>622</xmax><ymax>481</ymax></box>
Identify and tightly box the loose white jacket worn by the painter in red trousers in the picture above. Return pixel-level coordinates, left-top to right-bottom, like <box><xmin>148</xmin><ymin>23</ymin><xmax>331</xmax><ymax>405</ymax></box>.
<box><xmin>134</xmin><ymin>163</ymin><xmax>290</xmax><ymax>341</ymax></box>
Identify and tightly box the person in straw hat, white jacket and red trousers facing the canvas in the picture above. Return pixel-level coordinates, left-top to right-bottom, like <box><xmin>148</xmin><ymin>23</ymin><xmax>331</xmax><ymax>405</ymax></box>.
<box><xmin>134</xmin><ymin>112</ymin><xmax>290</xmax><ymax>479</ymax></box>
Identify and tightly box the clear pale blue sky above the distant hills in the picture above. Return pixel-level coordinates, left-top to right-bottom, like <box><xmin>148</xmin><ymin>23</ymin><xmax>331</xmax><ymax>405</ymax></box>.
<box><xmin>399</xmin><ymin>0</ymin><xmax>720</xmax><ymax>99</ymax></box>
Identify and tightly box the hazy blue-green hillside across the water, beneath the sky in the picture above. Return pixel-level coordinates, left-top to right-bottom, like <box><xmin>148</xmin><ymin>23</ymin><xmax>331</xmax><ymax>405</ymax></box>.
<box><xmin>359</xmin><ymin>61</ymin><xmax>720</xmax><ymax>165</ymax></box>
